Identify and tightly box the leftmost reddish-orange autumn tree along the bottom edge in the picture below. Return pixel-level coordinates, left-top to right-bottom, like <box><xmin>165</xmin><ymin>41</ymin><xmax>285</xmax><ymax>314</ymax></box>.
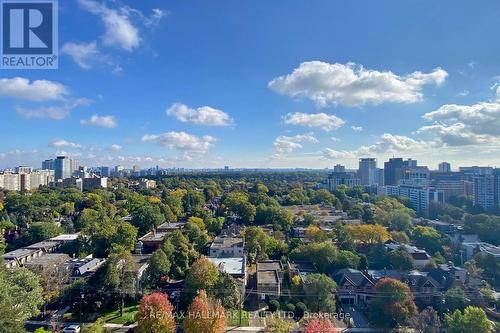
<box><xmin>136</xmin><ymin>293</ymin><xmax>176</xmax><ymax>333</ymax></box>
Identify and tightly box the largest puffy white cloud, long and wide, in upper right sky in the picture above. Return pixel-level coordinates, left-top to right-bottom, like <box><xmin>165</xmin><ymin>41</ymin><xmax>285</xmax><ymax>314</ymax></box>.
<box><xmin>268</xmin><ymin>61</ymin><xmax>448</xmax><ymax>107</ymax></box>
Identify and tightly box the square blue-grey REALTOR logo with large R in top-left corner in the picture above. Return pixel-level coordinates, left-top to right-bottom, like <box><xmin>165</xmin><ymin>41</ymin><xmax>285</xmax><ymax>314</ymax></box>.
<box><xmin>0</xmin><ymin>0</ymin><xmax>59</xmax><ymax>69</ymax></box>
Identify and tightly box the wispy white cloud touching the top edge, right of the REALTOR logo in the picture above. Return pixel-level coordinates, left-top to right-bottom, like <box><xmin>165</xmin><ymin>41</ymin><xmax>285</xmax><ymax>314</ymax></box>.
<box><xmin>79</xmin><ymin>0</ymin><xmax>141</xmax><ymax>51</ymax></box>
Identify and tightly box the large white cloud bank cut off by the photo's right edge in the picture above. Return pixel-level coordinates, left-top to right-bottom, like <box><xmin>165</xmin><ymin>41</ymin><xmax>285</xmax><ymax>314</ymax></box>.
<box><xmin>418</xmin><ymin>102</ymin><xmax>500</xmax><ymax>146</ymax></box>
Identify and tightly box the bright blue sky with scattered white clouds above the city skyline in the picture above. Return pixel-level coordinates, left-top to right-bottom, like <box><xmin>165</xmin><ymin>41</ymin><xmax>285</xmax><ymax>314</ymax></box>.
<box><xmin>0</xmin><ymin>0</ymin><xmax>500</xmax><ymax>168</ymax></box>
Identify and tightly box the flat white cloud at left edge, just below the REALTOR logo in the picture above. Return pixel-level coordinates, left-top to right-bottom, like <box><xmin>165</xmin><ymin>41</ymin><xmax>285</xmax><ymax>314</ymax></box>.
<box><xmin>0</xmin><ymin>77</ymin><xmax>69</xmax><ymax>102</ymax></box>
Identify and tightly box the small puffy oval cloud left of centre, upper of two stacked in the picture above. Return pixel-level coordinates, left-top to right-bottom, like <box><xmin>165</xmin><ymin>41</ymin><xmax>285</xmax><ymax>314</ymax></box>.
<box><xmin>166</xmin><ymin>103</ymin><xmax>232</xmax><ymax>126</ymax></box>
